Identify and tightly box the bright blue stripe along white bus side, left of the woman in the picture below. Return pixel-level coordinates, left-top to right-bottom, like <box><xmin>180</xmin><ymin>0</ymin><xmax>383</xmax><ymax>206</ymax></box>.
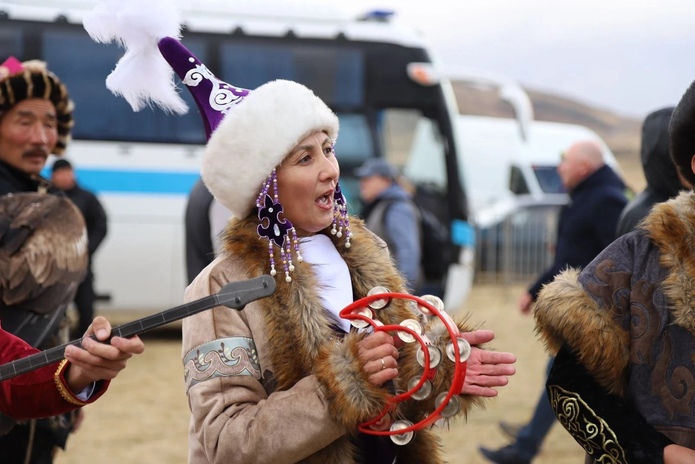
<box><xmin>42</xmin><ymin>169</ymin><xmax>199</xmax><ymax>195</ymax></box>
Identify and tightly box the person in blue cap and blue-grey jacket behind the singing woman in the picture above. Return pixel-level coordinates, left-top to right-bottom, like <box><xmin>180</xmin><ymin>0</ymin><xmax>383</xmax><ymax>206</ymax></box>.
<box><xmin>355</xmin><ymin>158</ymin><xmax>423</xmax><ymax>291</ymax></box>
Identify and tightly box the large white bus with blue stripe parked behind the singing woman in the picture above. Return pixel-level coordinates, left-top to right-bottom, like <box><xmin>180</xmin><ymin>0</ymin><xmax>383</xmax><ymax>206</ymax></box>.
<box><xmin>0</xmin><ymin>0</ymin><xmax>473</xmax><ymax>312</ymax></box>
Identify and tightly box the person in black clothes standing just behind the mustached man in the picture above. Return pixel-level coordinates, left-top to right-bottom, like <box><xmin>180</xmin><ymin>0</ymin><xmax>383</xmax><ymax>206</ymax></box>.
<box><xmin>51</xmin><ymin>158</ymin><xmax>107</xmax><ymax>338</ymax></box>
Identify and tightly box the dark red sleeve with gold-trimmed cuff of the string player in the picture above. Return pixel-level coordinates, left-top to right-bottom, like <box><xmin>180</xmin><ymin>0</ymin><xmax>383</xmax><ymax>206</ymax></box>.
<box><xmin>0</xmin><ymin>329</ymin><xmax>108</xmax><ymax>419</ymax></box>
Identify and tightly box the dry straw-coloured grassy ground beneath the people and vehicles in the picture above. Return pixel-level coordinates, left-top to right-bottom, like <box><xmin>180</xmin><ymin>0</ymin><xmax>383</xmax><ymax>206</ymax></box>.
<box><xmin>51</xmin><ymin>154</ymin><xmax>644</xmax><ymax>464</ymax></box>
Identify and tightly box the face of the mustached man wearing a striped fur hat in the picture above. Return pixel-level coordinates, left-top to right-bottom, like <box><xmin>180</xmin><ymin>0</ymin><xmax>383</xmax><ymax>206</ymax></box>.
<box><xmin>0</xmin><ymin>98</ymin><xmax>58</xmax><ymax>174</ymax></box>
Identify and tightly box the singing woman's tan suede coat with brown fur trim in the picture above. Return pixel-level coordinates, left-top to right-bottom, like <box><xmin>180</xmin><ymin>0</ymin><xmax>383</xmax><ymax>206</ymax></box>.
<box><xmin>182</xmin><ymin>218</ymin><xmax>478</xmax><ymax>464</ymax></box>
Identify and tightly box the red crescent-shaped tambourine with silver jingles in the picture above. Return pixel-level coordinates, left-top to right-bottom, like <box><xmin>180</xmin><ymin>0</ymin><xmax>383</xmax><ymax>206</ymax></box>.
<box><xmin>340</xmin><ymin>287</ymin><xmax>471</xmax><ymax>445</ymax></box>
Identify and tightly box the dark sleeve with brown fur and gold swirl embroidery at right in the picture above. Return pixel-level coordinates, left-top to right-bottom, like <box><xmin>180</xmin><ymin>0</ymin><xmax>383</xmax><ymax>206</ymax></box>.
<box><xmin>534</xmin><ymin>236</ymin><xmax>672</xmax><ymax>464</ymax></box>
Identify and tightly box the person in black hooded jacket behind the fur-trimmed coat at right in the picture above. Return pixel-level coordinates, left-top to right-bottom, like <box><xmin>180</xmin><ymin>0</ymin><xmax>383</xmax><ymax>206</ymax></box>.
<box><xmin>616</xmin><ymin>106</ymin><xmax>684</xmax><ymax>237</ymax></box>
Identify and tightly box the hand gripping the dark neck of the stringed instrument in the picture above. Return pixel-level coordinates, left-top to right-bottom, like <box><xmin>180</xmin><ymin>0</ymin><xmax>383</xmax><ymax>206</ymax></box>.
<box><xmin>65</xmin><ymin>316</ymin><xmax>145</xmax><ymax>393</ymax></box>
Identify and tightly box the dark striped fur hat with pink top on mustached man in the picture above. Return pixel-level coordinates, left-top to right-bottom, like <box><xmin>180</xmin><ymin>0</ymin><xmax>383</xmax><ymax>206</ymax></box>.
<box><xmin>0</xmin><ymin>58</ymin><xmax>75</xmax><ymax>155</ymax></box>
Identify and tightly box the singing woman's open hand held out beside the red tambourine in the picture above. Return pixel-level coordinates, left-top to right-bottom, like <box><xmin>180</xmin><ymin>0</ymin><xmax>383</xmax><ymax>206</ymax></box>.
<box><xmin>461</xmin><ymin>330</ymin><xmax>516</xmax><ymax>397</ymax></box>
